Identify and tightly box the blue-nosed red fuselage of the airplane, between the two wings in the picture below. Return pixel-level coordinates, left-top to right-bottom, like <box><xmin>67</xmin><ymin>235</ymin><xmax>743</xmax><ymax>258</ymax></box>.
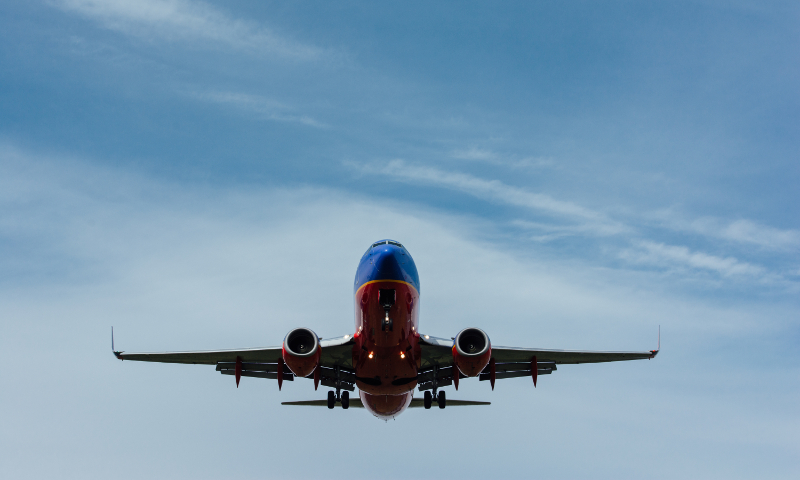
<box><xmin>353</xmin><ymin>240</ymin><xmax>420</xmax><ymax>418</ymax></box>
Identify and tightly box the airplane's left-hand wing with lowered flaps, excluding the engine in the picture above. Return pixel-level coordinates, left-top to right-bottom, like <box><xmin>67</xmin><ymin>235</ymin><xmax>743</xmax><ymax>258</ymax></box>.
<box><xmin>111</xmin><ymin>331</ymin><xmax>355</xmax><ymax>391</ymax></box>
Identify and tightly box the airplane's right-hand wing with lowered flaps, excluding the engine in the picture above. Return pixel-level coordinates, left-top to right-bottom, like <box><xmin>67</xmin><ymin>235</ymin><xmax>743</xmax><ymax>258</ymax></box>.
<box><xmin>417</xmin><ymin>335</ymin><xmax>660</xmax><ymax>391</ymax></box>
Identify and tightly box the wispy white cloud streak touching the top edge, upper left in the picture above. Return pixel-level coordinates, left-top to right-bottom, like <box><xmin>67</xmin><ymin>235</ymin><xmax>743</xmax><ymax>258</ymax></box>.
<box><xmin>54</xmin><ymin>0</ymin><xmax>322</xmax><ymax>60</ymax></box>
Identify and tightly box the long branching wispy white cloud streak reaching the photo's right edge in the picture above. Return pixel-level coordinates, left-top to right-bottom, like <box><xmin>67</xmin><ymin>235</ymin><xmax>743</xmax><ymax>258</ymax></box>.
<box><xmin>354</xmin><ymin>158</ymin><xmax>797</xmax><ymax>289</ymax></box>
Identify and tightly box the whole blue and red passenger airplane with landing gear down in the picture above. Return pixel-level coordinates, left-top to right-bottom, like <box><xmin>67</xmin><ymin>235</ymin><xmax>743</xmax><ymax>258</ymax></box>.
<box><xmin>111</xmin><ymin>239</ymin><xmax>661</xmax><ymax>421</ymax></box>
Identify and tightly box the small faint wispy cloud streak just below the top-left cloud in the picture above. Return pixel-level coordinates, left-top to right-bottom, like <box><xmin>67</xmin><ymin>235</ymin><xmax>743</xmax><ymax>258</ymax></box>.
<box><xmin>184</xmin><ymin>90</ymin><xmax>328</xmax><ymax>128</ymax></box>
